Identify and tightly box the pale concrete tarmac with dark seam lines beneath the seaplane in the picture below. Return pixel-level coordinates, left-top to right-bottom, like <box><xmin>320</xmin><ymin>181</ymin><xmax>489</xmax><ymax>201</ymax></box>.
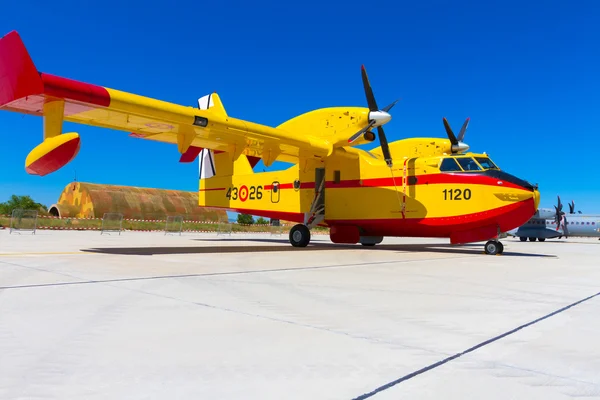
<box><xmin>0</xmin><ymin>230</ymin><xmax>600</xmax><ymax>400</ymax></box>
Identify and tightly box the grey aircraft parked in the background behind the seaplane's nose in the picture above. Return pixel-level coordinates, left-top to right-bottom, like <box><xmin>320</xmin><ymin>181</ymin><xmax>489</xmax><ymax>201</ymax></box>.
<box><xmin>506</xmin><ymin>196</ymin><xmax>600</xmax><ymax>242</ymax></box>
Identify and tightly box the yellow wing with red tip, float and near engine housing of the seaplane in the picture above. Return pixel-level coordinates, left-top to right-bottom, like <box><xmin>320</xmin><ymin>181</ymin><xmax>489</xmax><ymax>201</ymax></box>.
<box><xmin>0</xmin><ymin>31</ymin><xmax>380</xmax><ymax>175</ymax></box>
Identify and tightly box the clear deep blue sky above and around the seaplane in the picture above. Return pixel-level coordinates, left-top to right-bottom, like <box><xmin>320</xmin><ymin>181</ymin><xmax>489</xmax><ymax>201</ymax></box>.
<box><xmin>0</xmin><ymin>0</ymin><xmax>600</xmax><ymax>212</ymax></box>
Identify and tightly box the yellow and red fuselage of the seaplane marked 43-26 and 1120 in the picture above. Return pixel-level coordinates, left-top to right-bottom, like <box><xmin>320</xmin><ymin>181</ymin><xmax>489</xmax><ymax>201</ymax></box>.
<box><xmin>199</xmin><ymin>139</ymin><xmax>539</xmax><ymax>243</ymax></box>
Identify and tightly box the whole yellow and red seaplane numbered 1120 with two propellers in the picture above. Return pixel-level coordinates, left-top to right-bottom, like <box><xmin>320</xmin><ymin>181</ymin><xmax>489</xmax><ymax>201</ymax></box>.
<box><xmin>0</xmin><ymin>31</ymin><xmax>539</xmax><ymax>254</ymax></box>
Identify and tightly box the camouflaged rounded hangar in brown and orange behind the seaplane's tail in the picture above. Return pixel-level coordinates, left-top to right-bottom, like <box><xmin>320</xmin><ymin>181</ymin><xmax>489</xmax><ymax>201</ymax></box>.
<box><xmin>48</xmin><ymin>182</ymin><xmax>227</xmax><ymax>221</ymax></box>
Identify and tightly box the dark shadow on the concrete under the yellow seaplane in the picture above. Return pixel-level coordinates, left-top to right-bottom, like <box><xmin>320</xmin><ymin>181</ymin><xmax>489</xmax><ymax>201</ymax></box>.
<box><xmin>81</xmin><ymin>238</ymin><xmax>556</xmax><ymax>257</ymax></box>
